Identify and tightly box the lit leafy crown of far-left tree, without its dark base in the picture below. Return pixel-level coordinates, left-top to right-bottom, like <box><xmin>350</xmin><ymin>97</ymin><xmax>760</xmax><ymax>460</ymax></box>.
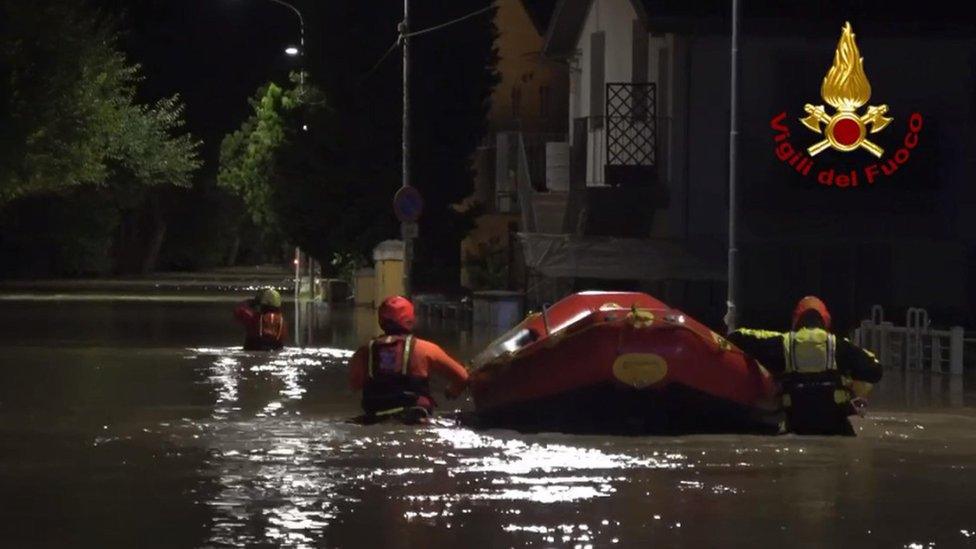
<box><xmin>0</xmin><ymin>0</ymin><xmax>200</xmax><ymax>204</ymax></box>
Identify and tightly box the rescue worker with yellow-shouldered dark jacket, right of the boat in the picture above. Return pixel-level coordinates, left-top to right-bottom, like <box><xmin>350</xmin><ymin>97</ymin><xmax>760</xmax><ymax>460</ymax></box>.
<box><xmin>728</xmin><ymin>296</ymin><xmax>881</xmax><ymax>436</ymax></box>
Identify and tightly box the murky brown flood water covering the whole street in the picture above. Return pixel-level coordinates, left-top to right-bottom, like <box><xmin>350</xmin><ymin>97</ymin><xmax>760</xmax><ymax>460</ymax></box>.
<box><xmin>0</xmin><ymin>296</ymin><xmax>976</xmax><ymax>548</ymax></box>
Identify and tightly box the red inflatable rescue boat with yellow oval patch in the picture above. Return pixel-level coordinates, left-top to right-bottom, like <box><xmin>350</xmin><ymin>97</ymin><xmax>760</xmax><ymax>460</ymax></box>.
<box><xmin>470</xmin><ymin>292</ymin><xmax>780</xmax><ymax>433</ymax></box>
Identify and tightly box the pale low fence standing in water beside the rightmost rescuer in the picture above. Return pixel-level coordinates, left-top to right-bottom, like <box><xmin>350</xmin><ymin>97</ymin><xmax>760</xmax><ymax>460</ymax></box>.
<box><xmin>854</xmin><ymin>305</ymin><xmax>965</xmax><ymax>374</ymax></box>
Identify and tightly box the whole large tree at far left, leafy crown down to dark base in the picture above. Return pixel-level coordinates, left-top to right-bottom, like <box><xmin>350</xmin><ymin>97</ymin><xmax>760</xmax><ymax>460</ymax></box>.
<box><xmin>0</xmin><ymin>0</ymin><xmax>201</xmax><ymax>274</ymax></box>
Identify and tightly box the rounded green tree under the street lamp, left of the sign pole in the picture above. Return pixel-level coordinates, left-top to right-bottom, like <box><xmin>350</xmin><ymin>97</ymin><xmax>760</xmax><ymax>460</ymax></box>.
<box><xmin>218</xmin><ymin>76</ymin><xmax>392</xmax><ymax>268</ymax></box>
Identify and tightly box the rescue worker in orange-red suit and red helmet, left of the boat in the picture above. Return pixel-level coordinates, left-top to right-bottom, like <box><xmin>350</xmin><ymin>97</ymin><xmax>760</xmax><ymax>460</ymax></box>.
<box><xmin>349</xmin><ymin>296</ymin><xmax>468</xmax><ymax>423</ymax></box>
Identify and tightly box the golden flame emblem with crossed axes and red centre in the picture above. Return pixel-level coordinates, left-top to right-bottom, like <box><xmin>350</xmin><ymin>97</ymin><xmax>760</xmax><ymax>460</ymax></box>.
<box><xmin>800</xmin><ymin>22</ymin><xmax>892</xmax><ymax>158</ymax></box>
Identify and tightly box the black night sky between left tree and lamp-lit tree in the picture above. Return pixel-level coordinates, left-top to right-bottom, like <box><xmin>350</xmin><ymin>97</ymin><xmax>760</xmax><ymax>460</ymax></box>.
<box><xmin>96</xmin><ymin>0</ymin><xmax>312</xmax><ymax>173</ymax></box>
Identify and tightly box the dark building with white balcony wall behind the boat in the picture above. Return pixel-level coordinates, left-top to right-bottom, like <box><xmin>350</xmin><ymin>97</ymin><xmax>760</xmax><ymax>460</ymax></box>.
<box><xmin>526</xmin><ymin>0</ymin><xmax>976</xmax><ymax>326</ymax></box>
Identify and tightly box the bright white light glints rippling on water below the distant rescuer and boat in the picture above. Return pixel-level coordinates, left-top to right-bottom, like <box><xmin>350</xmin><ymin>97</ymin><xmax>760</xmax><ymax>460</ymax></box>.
<box><xmin>188</xmin><ymin>348</ymin><xmax>716</xmax><ymax>546</ymax></box>
